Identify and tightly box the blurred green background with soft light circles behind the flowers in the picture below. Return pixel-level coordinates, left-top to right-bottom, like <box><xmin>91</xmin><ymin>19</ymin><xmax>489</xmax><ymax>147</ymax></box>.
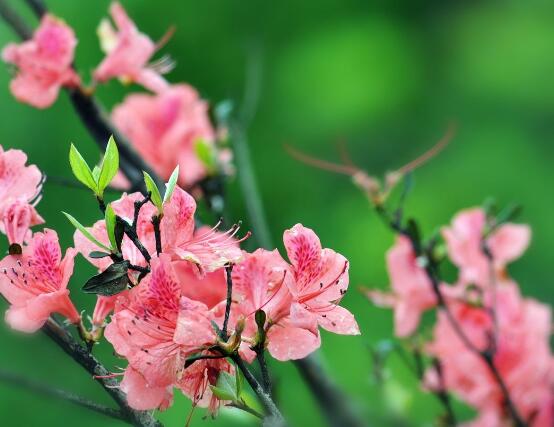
<box><xmin>0</xmin><ymin>0</ymin><xmax>554</xmax><ymax>427</ymax></box>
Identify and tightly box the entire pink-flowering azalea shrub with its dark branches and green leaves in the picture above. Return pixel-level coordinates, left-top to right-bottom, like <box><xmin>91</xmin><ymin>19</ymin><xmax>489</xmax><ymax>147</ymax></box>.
<box><xmin>0</xmin><ymin>2</ymin><xmax>554</xmax><ymax>427</ymax></box>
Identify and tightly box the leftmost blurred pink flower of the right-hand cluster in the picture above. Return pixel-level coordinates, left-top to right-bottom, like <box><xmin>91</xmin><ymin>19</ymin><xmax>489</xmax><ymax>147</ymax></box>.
<box><xmin>367</xmin><ymin>236</ymin><xmax>436</xmax><ymax>337</ymax></box>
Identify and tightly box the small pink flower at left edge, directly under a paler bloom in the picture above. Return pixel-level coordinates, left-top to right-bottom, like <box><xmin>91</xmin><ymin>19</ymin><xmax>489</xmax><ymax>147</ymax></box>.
<box><xmin>2</xmin><ymin>200</ymin><xmax>44</xmax><ymax>245</ymax></box>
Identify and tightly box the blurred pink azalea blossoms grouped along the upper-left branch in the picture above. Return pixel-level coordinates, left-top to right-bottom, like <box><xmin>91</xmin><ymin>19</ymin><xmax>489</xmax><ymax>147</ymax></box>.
<box><xmin>2</xmin><ymin>2</ymin><xmax>226</xmax><ymax>189</ymax></box>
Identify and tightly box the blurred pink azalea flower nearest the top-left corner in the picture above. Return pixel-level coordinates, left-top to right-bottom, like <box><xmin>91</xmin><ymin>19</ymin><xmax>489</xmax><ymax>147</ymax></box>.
<box><xmin>2</xmin><ymin>15</ymin><xmax>80</xmax><ymax>108</ymax></box>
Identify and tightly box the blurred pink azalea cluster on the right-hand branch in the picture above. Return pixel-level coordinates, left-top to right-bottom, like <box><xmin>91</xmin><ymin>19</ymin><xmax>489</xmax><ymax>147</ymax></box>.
<box><xmin>368</xmin><ymin>208</ymin><xmax>554</xmax><ymax>427</ymax></box>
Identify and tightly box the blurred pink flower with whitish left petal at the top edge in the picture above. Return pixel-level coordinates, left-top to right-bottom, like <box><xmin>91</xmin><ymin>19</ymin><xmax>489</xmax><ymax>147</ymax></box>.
<box><xmin>93</xmin><ymin>2</ymin><xmax>168</xmax><ymax>92</ymax></box>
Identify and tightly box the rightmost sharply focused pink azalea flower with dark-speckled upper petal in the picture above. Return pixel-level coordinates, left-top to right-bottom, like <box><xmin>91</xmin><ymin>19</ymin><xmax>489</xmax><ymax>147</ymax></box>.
<box><xmin>283</xmin><ymin>224</ymin><xmax>360</xmax><ymax>335</ymax></box>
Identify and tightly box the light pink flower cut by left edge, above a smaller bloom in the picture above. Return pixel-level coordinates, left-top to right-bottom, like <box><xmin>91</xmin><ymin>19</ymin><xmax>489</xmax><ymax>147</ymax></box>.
<box><xmin>0</xmin><ymin>146</ymin><xmax>42</xmax><ymax>219</ymax></box>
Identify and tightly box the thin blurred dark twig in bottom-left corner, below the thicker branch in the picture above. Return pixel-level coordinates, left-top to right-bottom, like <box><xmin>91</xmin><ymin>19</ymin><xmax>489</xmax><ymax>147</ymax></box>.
<box><xmin>0</xmin><ymin>370</ymin><xmax>127</xmax><ymax>421</ymax></box>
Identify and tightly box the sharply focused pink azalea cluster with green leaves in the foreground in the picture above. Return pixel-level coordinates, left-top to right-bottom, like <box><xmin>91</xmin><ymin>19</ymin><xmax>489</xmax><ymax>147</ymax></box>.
<box><xmin>0</xmin><ymin>141</ymin><xmax>359</xmax><ymax>413</ymax></box>
